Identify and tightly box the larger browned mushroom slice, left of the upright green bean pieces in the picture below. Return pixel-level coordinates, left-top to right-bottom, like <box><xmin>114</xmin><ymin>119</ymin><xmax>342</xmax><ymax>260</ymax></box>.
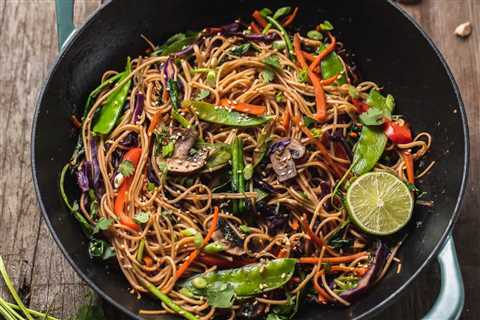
<box><xmin>161</xmin><ymin>128</ymin><xmax>208</xmax><ymax>174</ymax></box>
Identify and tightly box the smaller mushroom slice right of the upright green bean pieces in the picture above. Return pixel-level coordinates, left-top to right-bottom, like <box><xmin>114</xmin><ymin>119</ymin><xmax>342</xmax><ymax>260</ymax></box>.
<box><xmin>270</xmin><ymin>138</ymin><xmax>305</xmax><ymax>182</ymax></box>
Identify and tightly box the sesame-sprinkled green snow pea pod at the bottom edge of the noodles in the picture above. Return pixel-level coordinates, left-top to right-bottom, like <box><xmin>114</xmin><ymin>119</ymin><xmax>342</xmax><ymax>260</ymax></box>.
<box><xmin>182</xmin><ymin>258</ymin><xmax>297</xmax><ymax>297</ymax></box>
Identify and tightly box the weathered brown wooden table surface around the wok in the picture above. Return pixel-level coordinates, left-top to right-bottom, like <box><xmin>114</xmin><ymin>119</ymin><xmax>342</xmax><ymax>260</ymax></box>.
<box><xmin>0</xmin><ymin>0</ymin><xmax>480</xmax><ymax>320</ymax></box>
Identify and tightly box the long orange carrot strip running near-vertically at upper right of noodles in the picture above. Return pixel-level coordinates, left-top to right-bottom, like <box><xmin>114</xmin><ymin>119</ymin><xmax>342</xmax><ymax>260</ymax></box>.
<box><xmin>293</xmin><ymin>33</ymin><xmax>327</xmax><ymax>121</ymax></box>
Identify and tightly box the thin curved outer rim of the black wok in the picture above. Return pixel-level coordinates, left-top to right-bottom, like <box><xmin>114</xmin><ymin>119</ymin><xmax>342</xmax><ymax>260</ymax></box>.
<box><xmin>30</xmin><ymin>0</ymin><xmax>470</xmax><ymax>320</ymax></box>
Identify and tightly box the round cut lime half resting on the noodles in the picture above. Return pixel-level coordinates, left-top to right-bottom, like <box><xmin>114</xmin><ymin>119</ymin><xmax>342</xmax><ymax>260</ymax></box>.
<box><xmin>346</xmin><ymin>172</ymin><xmax>413</xmax><ymax>235</ymax></box>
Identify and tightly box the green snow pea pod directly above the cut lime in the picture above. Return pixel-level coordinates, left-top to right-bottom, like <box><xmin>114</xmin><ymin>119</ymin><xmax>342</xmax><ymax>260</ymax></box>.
<box><xmin>352</xmin><ymin>126</ymin><xmax>387</xmax><ymax>175</ymax></box>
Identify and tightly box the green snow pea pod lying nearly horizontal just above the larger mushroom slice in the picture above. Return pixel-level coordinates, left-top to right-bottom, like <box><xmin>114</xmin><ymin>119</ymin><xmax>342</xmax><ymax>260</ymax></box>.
<box><xmin>183</xmin><ymin>100</ymin><xmax>273</xmax><ymax>127</ymax></box>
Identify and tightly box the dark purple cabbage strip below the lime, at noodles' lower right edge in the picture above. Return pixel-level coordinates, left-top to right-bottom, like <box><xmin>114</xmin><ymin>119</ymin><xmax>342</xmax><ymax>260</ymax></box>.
<box><xmin>340</xmin><ymin>240</ymin><xmax>387</xmax><ymax>302</ymax></box>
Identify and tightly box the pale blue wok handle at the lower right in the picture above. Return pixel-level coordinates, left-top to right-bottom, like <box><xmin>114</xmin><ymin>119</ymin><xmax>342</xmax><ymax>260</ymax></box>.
<box><xmin>423</xmin><ymin>235</ymin><xmax>465</xmax><ymax>320</ymax></box>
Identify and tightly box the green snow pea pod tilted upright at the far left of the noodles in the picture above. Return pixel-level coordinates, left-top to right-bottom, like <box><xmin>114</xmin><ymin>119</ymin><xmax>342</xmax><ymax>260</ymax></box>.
<box><xmin>93</xmin><ymin>58</ymin><xmax>132</xmax><ymax>135</ymax></box>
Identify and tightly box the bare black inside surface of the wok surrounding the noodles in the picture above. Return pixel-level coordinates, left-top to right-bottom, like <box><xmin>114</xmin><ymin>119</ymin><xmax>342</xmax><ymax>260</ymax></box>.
<box><xmin>32</xmin><ymin>0</ymin><xmax>468</xmax><ymax>319</ymax></box>
